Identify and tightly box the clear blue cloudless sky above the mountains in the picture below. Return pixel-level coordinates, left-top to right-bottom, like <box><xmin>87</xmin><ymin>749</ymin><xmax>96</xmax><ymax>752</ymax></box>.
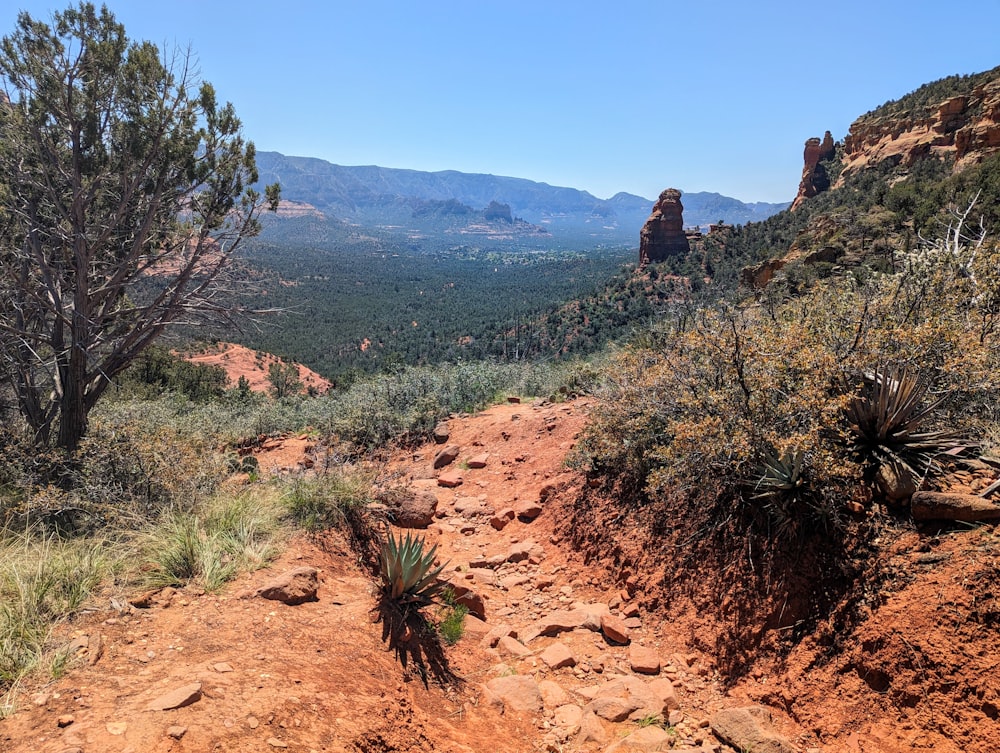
<box><xmin>0</xmin><ymin>0</ymin><xmax>1000</xmax><ymax>201</ymax></box>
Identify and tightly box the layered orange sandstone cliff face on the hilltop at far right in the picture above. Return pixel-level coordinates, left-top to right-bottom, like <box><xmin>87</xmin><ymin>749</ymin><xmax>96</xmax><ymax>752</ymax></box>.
<box><xmin>838</xmin><ymin>76</ymin><xmax>1000</xmax><ymax>184</ymax></box>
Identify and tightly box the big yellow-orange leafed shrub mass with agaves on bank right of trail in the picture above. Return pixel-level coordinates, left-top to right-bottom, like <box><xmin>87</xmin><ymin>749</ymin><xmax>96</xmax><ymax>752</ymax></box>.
<box><xmin>583</xmin><ymin>198</ymin><xmax>1000</xmax><ymax>664</ymax></box>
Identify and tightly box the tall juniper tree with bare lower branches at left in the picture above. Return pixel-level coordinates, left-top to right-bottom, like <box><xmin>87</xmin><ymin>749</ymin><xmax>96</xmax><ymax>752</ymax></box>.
<box><xmin>0</xmin><ymin>3</ymin><xmax>278</xmax><ymax>450</ymax></box>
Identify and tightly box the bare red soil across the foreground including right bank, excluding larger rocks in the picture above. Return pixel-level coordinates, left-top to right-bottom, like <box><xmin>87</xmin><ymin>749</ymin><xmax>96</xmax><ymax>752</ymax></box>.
<box><xmin>0</xmin><ymin>401</ymin><xmax>1000</xmax><ymax>753</ymax></box>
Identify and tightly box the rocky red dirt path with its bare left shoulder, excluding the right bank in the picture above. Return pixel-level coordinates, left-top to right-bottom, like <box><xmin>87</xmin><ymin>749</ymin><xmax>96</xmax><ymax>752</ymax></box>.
<box><xmin>0</xmin><ymin>402</ymin><xmax>740</xmax><ymax>753</ymax></box>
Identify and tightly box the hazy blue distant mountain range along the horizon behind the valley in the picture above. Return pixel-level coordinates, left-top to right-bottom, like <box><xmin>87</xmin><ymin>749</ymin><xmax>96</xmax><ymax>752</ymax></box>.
<box><xmin>257</xmin><ymin>152</ymin><xmax>789</xmax><ymax>244</ymax></box>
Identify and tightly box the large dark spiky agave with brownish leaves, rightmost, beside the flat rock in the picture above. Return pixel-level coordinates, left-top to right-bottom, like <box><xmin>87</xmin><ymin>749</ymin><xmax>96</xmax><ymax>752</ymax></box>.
<box><xmin>845</xmin><ymin>367</ymin><xmax>958</xmax><ymax>478</ymax></box>
